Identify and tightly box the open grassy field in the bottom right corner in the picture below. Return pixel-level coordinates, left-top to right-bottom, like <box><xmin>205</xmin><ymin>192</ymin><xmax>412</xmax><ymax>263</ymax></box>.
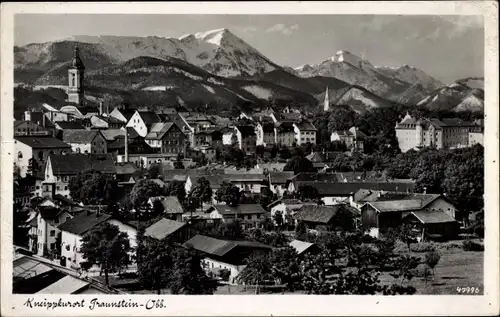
<box><xmin>380</xmin><ymin>242</ymin><xmax>484</xmax><ymax>295</ymax></box>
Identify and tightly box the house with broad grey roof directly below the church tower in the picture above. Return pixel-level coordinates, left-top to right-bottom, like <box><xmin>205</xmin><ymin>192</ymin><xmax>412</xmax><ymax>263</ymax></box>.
<box><xmin>63</xmin><ymin>130</ymin><xmax>107</xmax><ymax>154</ymax></box>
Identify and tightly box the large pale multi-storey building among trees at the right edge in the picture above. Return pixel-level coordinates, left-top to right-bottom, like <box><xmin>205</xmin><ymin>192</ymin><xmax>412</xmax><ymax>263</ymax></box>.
<box><xmin>396</xmin><ymin>113</ymin><xmax>483</xmax><ymax>152</ymax></box>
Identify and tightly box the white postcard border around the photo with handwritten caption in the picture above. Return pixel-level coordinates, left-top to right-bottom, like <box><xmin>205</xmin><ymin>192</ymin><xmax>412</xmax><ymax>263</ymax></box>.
<box><xmin>0</xmin><ymin>1</ymin><xmax>499</xmax><ymax>316</ymax></box>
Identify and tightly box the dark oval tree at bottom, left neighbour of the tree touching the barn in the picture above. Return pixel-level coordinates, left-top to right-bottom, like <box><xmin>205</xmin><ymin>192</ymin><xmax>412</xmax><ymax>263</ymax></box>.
<box><xmin>137</xmin><ymin>238</ymin><xmax>174</xmax><ymax>295</ymax></box>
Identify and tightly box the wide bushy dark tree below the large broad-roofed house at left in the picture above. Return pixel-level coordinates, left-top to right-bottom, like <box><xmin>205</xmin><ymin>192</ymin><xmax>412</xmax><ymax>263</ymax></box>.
<box><xmin>68</xmin><ymin>171</ymin><xmax>119</xmax><ymax>205</ymax></box>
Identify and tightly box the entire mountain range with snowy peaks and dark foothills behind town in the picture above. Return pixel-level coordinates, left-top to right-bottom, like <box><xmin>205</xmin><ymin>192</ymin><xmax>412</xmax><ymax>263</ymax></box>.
<box><xmin>14</xmin><ymin>29</ymin><xmax>484</xmax><ymax>112</ymax></box>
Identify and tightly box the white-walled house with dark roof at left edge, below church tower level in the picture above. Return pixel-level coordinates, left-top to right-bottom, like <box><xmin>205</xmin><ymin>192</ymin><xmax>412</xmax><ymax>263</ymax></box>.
<box><xmin>14</xmin><ymin>136</ymin><xmax>71</xmax><ymax>177</ymax></box>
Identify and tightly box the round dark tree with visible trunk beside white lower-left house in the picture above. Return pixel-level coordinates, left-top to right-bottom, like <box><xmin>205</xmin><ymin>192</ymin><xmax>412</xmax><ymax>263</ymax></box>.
<box><xmin>80</xmin><ymin>222</ymin><xmax>131</xmax><ymax>286</ymax></box>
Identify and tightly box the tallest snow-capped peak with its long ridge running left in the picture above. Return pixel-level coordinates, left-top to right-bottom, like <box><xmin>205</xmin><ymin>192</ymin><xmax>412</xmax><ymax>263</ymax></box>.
<box><xmin>62</xmin><ymin>28</ymin><xmax>279</xmax><ymax>77</ymax></box>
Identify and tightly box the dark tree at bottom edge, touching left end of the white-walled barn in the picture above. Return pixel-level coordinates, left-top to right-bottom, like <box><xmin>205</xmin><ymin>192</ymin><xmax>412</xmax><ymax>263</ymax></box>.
<box><xmin>170</xmin><ymin>248</ymin><xmax>217</xmax><ymax>295</ymax></box>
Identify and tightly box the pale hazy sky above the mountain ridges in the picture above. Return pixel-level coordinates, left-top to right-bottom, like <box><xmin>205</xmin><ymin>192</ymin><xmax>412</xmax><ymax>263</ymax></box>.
<box><xmin>14</xmin><ymin>14</ymin><xmax>484</xmax><ymax>83</ymax></box>
